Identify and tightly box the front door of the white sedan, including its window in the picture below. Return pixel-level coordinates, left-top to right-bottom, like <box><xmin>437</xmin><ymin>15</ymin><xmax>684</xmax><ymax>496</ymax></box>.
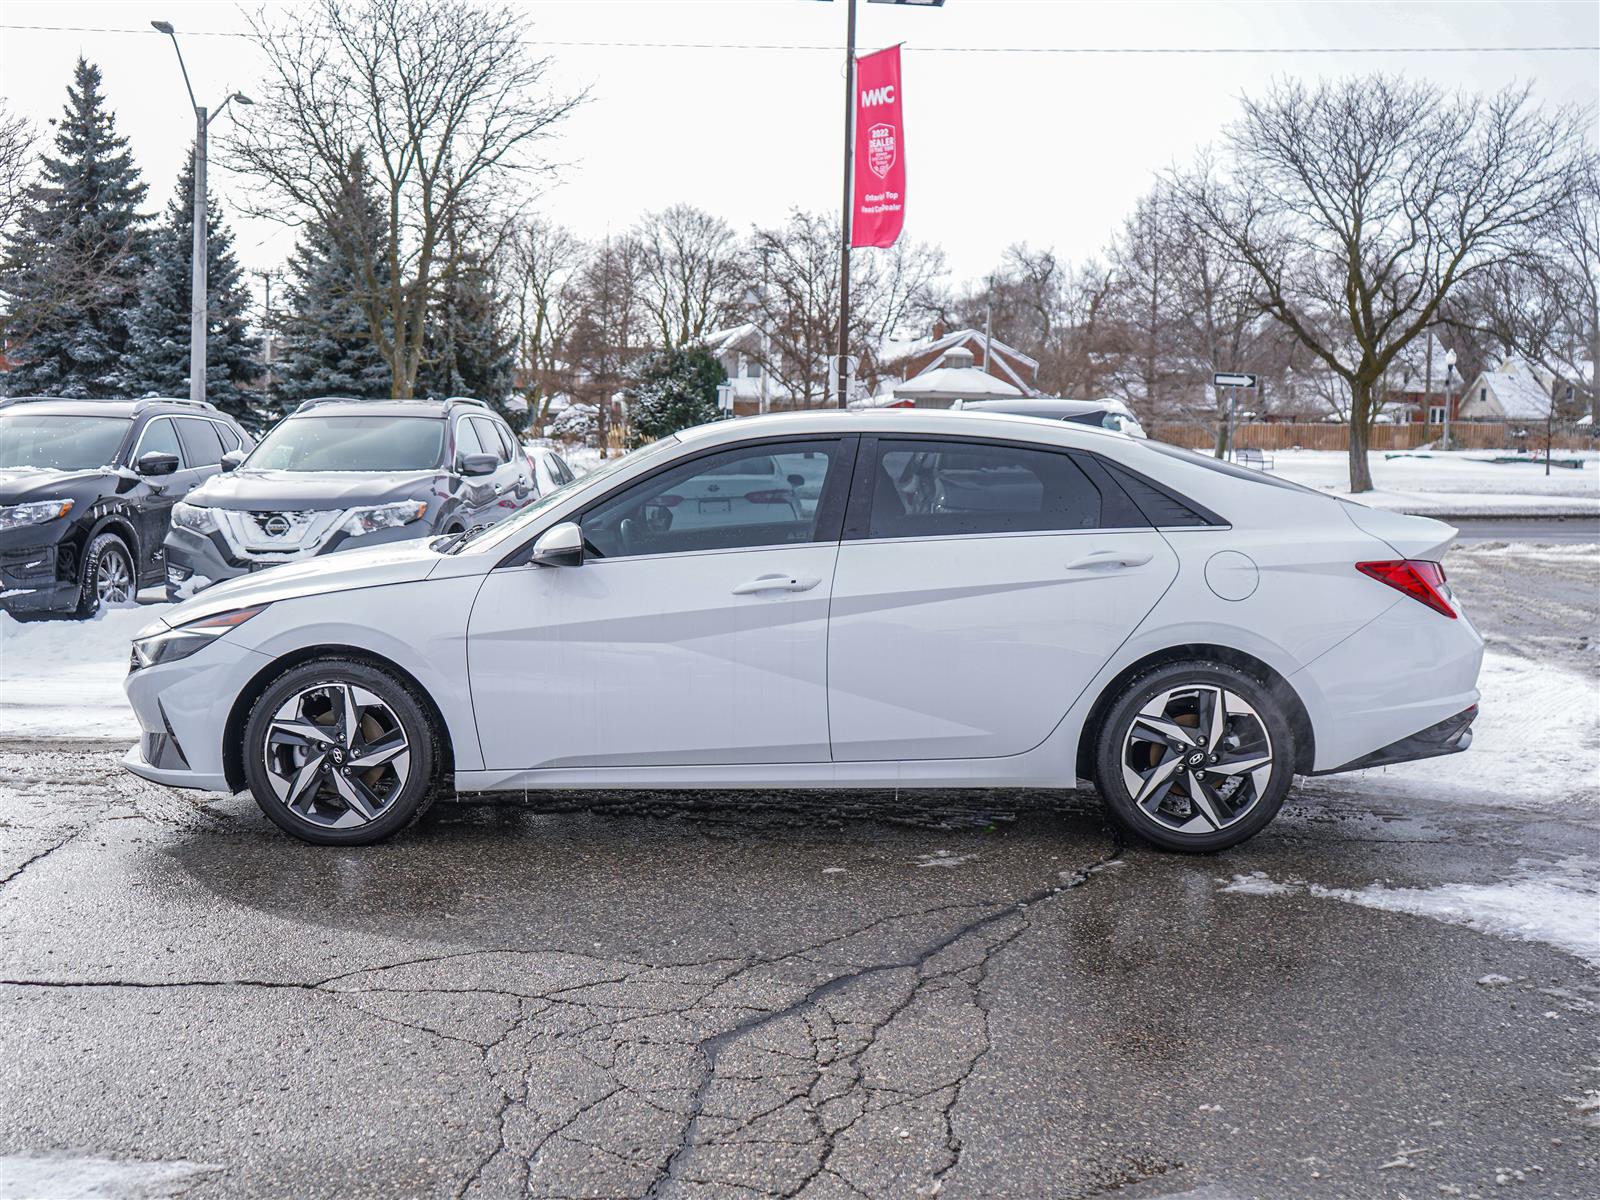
<box><xmin>467</xmin><ymin>437</ymin><xmax>854</xmax><ymax>770</ymax></box>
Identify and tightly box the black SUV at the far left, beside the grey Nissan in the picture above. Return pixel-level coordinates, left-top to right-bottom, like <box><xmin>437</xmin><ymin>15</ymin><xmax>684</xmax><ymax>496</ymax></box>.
<box><xmin>0</xmin><ymin>397</ymin><xmax>254</xmax><ymax>616</ymax></box>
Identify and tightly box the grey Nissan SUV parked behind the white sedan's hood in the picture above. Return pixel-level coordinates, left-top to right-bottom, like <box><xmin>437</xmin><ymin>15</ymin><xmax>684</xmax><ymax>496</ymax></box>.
<box><xmin>166</xmin><ymin>397</ymin><xmax>536</xmax><ymax>597</ymax></box>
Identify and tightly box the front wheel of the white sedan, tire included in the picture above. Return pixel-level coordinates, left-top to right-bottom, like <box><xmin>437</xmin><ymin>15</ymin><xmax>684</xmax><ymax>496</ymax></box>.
<box><xmin>243</xmin><ymin>658</ymin><xmax>442</xmax><ymax>846</ymax></box>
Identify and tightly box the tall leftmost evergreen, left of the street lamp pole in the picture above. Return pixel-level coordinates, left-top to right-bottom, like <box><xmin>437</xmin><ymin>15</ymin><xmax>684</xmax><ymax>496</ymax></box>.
<box><xmin>0</xmin><ymin>58</ymin><xmax>147</xmax><ymax>397</ymax></box>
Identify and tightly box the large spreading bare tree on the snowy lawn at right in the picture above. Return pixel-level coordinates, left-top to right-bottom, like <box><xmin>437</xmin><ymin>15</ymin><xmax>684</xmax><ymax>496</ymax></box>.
<box><xmin>1173</xmin><ymin>75</ymin><xmax>1589</xmax><ymax>491</ymax></box>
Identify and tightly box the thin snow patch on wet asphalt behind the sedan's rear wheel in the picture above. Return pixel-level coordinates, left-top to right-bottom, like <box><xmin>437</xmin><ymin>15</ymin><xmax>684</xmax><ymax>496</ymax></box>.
<box><xmin>1222</xmin><ymin>856</ymin><xmax>1600</xmax><ymax>966</ymax></box>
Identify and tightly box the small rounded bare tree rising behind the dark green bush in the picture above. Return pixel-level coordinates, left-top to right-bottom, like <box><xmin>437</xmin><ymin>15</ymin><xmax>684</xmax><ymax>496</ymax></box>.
<box><xmin>635</xmin><ymin>205</ymin><xmax>739</xmax><ymax>349</ymax></box>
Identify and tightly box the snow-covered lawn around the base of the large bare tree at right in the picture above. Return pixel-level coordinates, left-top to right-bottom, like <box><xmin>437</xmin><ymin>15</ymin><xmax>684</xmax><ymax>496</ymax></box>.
<box><xmin>1270</xmin><ymin>450</ymin><xmax>1600</xmax><ymax>517</ymax></box>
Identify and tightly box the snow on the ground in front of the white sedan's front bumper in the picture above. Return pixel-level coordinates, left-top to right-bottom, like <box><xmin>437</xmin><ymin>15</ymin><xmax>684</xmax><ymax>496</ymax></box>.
<box><xmin>0</xmin><ymin>605</ymin><xmax>170</xmax><ymax>742</ymax></box>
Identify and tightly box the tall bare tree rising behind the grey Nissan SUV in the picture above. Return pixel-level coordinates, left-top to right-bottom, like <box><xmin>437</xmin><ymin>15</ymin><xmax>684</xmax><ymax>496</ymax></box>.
<box><xmin>230</xmin><ymin>0</ymin><xmax>582</xmax><ymax>397</ymax></box>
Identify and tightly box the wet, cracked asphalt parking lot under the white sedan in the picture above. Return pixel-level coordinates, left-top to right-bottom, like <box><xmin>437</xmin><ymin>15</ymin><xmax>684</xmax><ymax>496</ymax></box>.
<box><xmin>0</xmin><ymin>542</ymin><xmax>1600</xmax><ymax>1200</ymax></box>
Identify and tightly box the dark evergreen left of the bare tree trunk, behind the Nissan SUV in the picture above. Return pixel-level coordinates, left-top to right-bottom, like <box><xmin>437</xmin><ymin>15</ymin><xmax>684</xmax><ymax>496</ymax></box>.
<box><xmin>274</xmin><ymin>160</ymin><xmax>394</xmax><ymax>408</ymax></box>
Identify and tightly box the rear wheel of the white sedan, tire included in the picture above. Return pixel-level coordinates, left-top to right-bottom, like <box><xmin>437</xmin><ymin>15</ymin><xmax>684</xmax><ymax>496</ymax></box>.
<box><xmin>1094</xmin><ymin>661</ymin><xmax>1294</xmax><ymax>853</ymax></box>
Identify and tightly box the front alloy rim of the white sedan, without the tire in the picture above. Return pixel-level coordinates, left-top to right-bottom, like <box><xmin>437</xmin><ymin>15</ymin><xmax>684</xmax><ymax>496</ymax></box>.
<box><xmin>262</xmin><ymin>683</ymin><xmax>411</xmax><ymax>829</ymax></box>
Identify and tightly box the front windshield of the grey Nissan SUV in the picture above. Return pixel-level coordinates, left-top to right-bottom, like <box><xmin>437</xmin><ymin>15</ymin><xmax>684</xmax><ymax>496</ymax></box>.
<box><xmin>248</xmin><ymin>416</ymin><xmax>445</xmax><ymax>470</ymax></box>
